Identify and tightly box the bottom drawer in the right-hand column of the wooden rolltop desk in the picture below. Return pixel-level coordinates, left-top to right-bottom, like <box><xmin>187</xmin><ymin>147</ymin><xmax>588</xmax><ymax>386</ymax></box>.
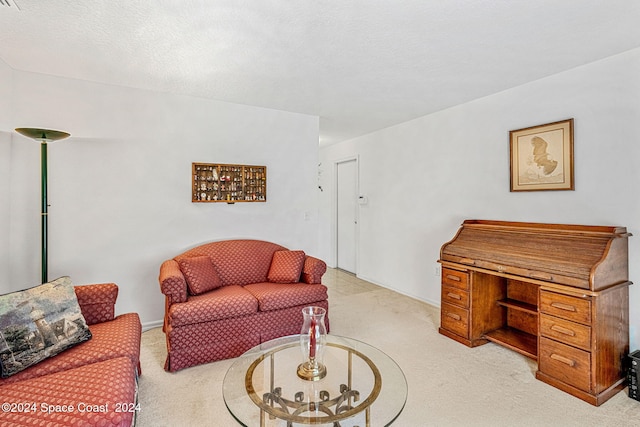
<box><xmin>538</xmin><ymin>337</ymin><xmax>591</xmax><ymax>392</ymax></box>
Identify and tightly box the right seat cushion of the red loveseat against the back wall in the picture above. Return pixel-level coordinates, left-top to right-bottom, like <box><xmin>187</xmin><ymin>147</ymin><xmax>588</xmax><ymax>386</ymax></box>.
<box><xmin>244</xmin><ymin>282</ymin><xmax>328</xmax><ymax>311</ymax></box>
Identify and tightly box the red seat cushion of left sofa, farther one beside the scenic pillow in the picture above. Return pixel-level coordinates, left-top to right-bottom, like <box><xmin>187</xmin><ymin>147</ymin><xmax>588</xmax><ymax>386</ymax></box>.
<box><xmin>0</xmin><ymin>313</ymin><xmax>142</xmax><ymax>386</ymax></box>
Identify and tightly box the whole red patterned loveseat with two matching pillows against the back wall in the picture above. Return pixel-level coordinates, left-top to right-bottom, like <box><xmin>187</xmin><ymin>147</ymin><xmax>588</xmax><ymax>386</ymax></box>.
<box><xmin>159</xmin><ymin>240</ymin><xmax>329</xmax><ymax>371</ymax></box>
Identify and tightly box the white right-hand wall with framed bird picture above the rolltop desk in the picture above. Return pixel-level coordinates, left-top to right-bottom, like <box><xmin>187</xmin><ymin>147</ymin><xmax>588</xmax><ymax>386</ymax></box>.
<box><xmin>320</xmin><ymin>49</ymin><xmax>640</xmax><ymax>348</ymax></box>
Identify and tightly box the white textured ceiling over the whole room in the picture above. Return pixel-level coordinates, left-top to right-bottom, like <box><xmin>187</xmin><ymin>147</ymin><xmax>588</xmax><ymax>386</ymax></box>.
<box><xmin>0</xmin><ymin>0</ymin><xmax>640</xmax><ymax>143</ymax></box>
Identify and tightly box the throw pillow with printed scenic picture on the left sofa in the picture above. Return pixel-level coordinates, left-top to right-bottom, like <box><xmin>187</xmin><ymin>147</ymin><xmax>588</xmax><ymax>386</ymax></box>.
<box><xmin>0</xmin><ymin>277</ymin><xmax>91</xmax><ymax>378</ymax></box>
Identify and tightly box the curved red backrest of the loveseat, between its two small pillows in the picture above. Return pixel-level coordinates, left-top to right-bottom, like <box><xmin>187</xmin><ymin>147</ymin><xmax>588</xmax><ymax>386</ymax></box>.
<box><xmin>174</xmin><ymin>239</ymin><xmax>286</xmax><ymax>286</ymax></box>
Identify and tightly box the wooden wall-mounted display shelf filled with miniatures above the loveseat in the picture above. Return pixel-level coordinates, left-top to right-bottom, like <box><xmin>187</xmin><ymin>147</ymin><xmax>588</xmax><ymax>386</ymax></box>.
<box><xmin>191</xmin><ymin>163</ymin><xmax>267</xmax><ymax>203</ymax></box>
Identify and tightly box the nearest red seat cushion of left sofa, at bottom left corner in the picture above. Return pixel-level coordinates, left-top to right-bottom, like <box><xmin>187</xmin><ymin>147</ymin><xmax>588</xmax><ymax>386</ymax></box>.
<box><xmin>0</xmin><ymin>357</ymin><xmax>140</xmax><ymax>427</ymax></box>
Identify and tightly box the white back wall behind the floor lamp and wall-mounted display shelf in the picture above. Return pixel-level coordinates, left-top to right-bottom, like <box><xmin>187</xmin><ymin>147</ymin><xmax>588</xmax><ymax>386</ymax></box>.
<box><xmin>6</xmin><ymin>71</ymin><xmax>318</xmax><ymax>325</ymax></box>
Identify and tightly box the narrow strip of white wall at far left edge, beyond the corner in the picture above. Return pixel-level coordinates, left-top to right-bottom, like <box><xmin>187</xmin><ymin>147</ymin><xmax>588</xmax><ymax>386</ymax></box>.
<box><xmin>0</xmin><ymin>59</ymin><xmax>13</xmax><ymax>283</ymax></box>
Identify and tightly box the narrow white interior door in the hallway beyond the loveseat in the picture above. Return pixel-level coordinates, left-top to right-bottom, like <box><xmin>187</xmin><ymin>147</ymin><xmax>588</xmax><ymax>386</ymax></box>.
<box><xmin>336</xmin><ymin>159</ymin><xmax>358</xmax><ymax>274</ymax></box>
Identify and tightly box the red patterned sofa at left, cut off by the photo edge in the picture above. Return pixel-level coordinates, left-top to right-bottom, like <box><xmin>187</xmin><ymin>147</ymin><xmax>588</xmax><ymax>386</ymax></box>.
<box><xmin>0</xmin><ymin>283</ymin><xmax>142</xmax><ymax>427</ymax></box>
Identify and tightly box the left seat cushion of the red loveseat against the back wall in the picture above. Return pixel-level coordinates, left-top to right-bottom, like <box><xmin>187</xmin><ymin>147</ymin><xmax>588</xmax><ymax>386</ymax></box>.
<box><xmin>169</xmin><ymin>285</ymin><xmax>258</xmax><ymax>327</ymax></box>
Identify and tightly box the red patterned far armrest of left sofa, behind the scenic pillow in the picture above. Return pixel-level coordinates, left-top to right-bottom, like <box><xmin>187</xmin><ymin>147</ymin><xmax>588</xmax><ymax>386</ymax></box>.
<box><xmin>74</xmin><ymin>283</ymin><xmax>118</xmax><ymax>325</ymax></box>
